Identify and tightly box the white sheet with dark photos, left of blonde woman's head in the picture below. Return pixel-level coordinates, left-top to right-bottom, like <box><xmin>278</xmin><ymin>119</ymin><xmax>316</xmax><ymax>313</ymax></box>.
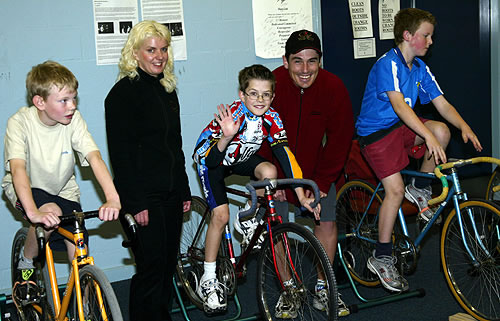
<box><xmin>93</xmin><ymin>0</ymin><xmax>138</xmax><ymax>65</ymax></box>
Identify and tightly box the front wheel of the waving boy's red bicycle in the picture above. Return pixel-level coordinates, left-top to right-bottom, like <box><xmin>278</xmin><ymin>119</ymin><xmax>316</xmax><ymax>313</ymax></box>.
<box><xmin>257</xmin><ymin>223</ymin><xmax>337</xmax><ymax>321</ymax></box>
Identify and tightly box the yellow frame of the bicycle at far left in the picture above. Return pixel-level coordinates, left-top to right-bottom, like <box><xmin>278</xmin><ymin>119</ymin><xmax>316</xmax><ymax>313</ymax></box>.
<box><xmin>45</xmin><ymin>213</ymin><xmax>107</xmax><ymax>321</ymax></box>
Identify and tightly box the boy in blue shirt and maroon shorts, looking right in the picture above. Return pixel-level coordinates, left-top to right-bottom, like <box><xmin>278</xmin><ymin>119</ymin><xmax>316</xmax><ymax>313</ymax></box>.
<box><xmin>356</xmin><ymin>8</ymin><xmax>482</xmax><ymax>292</ymax></box>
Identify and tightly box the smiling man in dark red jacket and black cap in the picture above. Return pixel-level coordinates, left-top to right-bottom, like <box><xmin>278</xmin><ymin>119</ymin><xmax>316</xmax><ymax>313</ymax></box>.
<box><xmin>261</xmin><ymin>30</ymin><xmax>354</xmax><ymax>315</ymax></box>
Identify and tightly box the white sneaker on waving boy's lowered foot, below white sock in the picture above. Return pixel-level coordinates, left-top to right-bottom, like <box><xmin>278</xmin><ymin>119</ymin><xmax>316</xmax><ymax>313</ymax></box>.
<box><xmin>196</xmin><ymin>278</ymin><xmax>227</xmax><ymax>314</ymax></box>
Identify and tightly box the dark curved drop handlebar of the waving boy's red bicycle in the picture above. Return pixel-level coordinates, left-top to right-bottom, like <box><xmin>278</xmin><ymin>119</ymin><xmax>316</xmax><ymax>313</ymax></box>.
<box><xmin>239</xmin><ymin>178</ymin><xmax>320</xmax><ymax>219</ymax></box>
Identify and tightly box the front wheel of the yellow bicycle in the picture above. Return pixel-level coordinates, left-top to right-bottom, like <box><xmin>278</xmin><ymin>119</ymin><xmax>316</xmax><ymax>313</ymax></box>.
<box><xmin>72</xmin><ymin>265</ymin><xmax>123</xmax><ymax>321</ymax></box>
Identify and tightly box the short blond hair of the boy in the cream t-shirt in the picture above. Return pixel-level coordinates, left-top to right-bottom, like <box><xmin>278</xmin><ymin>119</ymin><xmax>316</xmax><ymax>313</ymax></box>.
<box><xmin>26</xmin><ymin>60</ymin><xmax>78</xmax><ymax>104</ymax></box>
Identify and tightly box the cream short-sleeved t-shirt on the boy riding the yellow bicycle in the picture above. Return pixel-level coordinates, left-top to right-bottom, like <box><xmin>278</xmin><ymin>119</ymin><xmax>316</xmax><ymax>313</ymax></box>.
<box><xmin>2</xmin><ymin>106</ymin><xmax>99</xmax><ymax>205</ymax></box>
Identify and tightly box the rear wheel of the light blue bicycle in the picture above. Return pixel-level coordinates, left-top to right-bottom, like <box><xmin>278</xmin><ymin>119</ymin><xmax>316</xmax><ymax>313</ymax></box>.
<box><xmin>336</xmin><ymin>180</ymin><xmax>382</xmax><ymax>286</ymax></box>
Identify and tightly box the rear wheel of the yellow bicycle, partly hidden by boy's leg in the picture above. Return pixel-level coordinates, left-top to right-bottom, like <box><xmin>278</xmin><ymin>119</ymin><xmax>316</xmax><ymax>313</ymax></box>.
<box><xmin>10</xmin><ymin>227</ymin><xmax>54</xmax><ymax>320</ymax></box>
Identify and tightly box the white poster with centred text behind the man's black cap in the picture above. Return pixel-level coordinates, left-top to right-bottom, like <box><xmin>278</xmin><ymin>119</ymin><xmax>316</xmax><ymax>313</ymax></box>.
<box><xmin>252</xmin><ymin>0</ymin><xmax>313</xmax><ymax>58</ymax></box>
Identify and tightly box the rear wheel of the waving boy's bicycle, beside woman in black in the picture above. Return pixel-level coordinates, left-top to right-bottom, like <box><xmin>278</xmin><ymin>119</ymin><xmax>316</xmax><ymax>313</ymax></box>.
<box><xmin>177</xmin><ymin>196</ymin><xmax>210</xmax><ymax>309</ymax></box>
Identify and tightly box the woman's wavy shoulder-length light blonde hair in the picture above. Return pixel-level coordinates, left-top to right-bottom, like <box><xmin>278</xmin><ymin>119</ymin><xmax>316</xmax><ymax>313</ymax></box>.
<box><xmin>118</xmin><ymin>20</ymin><xmax>177</xmax><ymax>93</ymax></box>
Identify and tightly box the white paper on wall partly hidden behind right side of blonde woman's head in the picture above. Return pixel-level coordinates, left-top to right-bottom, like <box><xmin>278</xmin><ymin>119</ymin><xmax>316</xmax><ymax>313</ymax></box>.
<box><xmin>141</xmin><ymin>0</ymin><xmax>187</xmax><ymax>60</ymax></box>
